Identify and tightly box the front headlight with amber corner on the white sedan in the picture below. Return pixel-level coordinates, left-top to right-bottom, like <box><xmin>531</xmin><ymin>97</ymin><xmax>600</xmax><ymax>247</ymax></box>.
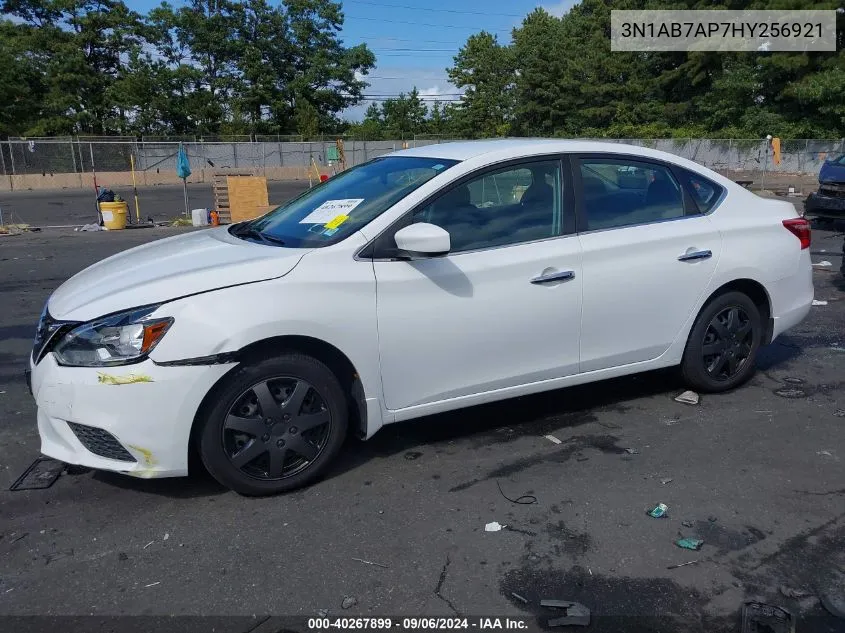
<box><xmin>53</xmin><ymin>306</ymin><xmax>173</xmax><ymax>367</ymax></box>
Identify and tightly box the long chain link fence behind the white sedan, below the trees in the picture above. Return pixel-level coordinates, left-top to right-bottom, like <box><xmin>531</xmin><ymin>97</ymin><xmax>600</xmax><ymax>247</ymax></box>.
<box><xmin>0</xmin><ymin>136</ymin><xmax>845</xmax><ymax>176</ymax></box>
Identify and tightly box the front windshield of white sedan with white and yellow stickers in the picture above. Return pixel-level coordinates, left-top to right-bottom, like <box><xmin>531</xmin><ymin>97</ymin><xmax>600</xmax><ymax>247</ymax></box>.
<box><xmin>231</xmin><ymin>156</ymin><xmax>457</xmax><ymax>248</ymax></box>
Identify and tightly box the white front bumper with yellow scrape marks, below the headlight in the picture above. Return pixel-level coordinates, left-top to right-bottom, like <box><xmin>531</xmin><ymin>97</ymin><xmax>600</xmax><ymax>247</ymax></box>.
<box><xmin>31</xmin><ymin>354</ymin><xmax>232</xmax><ymax>478</ymax></box>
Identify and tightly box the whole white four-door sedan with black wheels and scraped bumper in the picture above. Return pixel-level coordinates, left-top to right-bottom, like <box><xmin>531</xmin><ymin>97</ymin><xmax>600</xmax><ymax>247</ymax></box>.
<box><xmin>30</xmin><ymin>140</ymin><xmax>813</xmax><ymax>495</ymax></box>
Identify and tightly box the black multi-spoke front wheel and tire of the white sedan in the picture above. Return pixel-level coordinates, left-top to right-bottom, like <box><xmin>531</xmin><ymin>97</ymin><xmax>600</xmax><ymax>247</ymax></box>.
<box><xmin>197</xmin><ymin>353</ymin><xmax>348</xmax><ymax>496</ymax></box>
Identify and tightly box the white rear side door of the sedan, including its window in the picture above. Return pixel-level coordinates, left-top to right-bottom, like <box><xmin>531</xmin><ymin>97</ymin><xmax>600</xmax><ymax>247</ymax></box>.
<box><xmin>572</xmin><ymin>154</ymin><xmax>722</xmax><ymax>372</ymax></box>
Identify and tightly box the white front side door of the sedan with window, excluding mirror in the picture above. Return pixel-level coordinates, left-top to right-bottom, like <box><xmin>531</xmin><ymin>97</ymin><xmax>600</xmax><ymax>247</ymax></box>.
<box><xmin>374</xmin><ymin>157</ymin><xmax>582</xmax><ymax>410</ymax></box>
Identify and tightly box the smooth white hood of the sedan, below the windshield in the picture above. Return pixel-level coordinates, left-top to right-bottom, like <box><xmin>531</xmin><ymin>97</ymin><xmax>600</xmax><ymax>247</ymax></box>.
<box><xmin>47</xmin><ymin>227</ymin><xmax>309</xmax><ymax>321</ymax></box>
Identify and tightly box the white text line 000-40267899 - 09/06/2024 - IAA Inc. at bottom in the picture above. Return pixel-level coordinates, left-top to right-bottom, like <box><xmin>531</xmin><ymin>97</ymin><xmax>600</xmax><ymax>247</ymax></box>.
<box><xmin>308</xmin><ymin>617</ymin><xmax>528</xmax><ymax>631</ymax></box>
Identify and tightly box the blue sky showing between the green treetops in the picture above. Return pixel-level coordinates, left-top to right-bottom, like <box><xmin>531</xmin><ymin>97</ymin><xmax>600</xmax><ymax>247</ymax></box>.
<box><xmin>125</xmin><ymin>0</ymin><xmax>577</xmax><ymax>120</ymax></box>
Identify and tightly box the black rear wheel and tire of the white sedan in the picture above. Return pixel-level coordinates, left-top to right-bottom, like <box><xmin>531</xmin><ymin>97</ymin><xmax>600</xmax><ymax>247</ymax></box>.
<box><xmin>681</xmin><ymin>291</ymin><xmax>763</xmax><ymax>393</ymax></box>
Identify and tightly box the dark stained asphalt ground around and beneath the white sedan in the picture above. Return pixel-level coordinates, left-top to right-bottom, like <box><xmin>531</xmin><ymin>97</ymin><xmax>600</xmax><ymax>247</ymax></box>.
<box><xmin>0</xmin><ymin>195</ymin><xmax>845</xmax><ymax>633</ymax></box>
